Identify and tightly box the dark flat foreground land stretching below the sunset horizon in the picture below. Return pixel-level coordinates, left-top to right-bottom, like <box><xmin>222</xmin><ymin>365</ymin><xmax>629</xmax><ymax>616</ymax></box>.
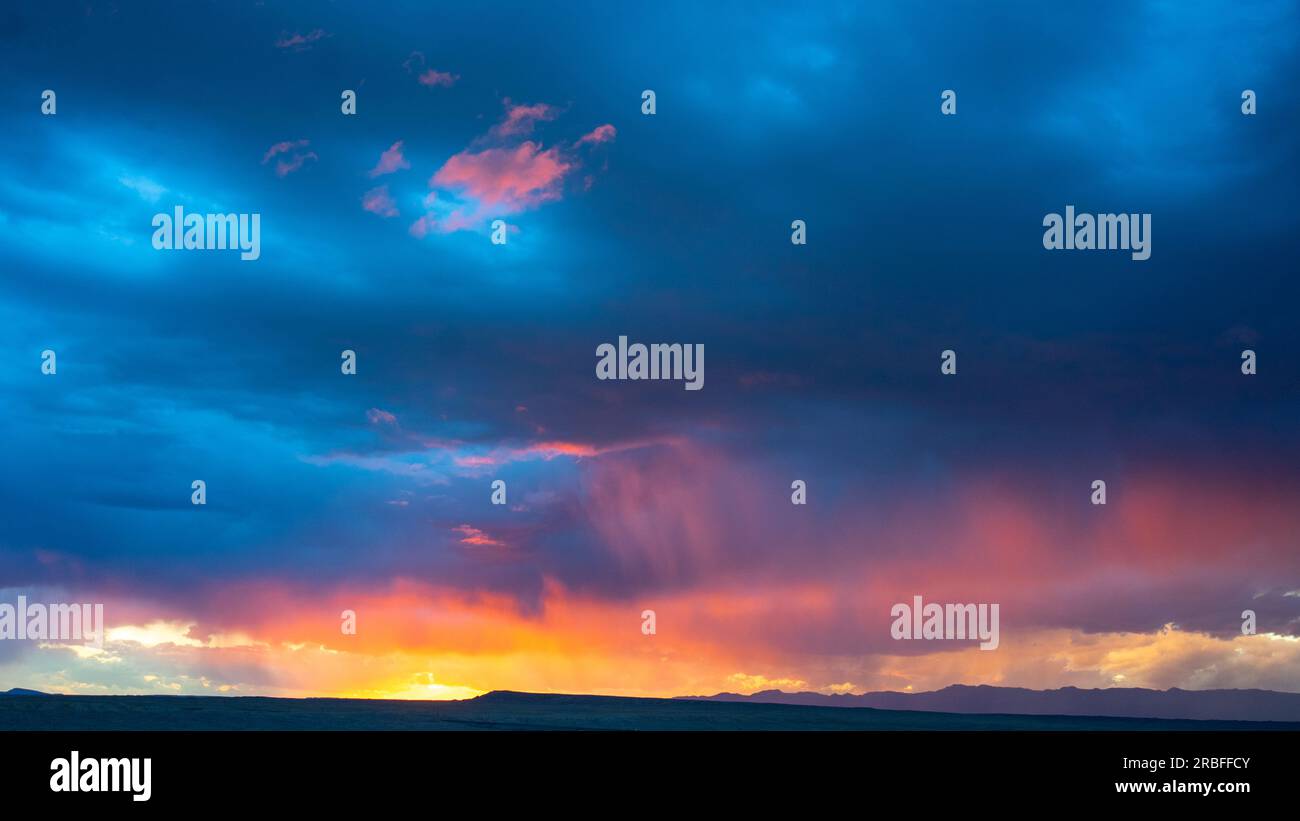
<box><xmin>0</xmin><ymin>692</ymin><xmax>1300</xmax><ymax>731</ymax></box>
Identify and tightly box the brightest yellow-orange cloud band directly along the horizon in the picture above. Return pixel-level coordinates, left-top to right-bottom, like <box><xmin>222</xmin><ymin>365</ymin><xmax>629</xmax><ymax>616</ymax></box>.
<box><xmin>25</xmin><ymin>576</ymin><xmax>1300</xmax><ymax>698</ymax></box>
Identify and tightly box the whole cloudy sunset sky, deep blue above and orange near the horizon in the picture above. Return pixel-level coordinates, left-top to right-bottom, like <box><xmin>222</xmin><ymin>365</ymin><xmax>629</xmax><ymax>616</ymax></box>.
<box><xmin>0</xmin><ymin>1</ymin><xmax>1300</xmax><ymax>699</ymax></box>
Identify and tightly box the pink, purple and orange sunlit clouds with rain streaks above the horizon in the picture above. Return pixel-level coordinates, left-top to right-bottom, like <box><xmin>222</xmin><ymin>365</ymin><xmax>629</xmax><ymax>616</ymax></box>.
<box><xmin>23</xmin><ymin>439</ymin><xmax>1300</xmax><ymax>698</ymax></box>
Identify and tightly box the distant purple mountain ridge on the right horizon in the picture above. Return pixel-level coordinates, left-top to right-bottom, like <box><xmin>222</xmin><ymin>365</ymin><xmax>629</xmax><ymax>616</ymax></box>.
<box><xmin>679</xmin><ymin>685</ymin><xmax>1300</xmax><ymax>721</ymax></box>
